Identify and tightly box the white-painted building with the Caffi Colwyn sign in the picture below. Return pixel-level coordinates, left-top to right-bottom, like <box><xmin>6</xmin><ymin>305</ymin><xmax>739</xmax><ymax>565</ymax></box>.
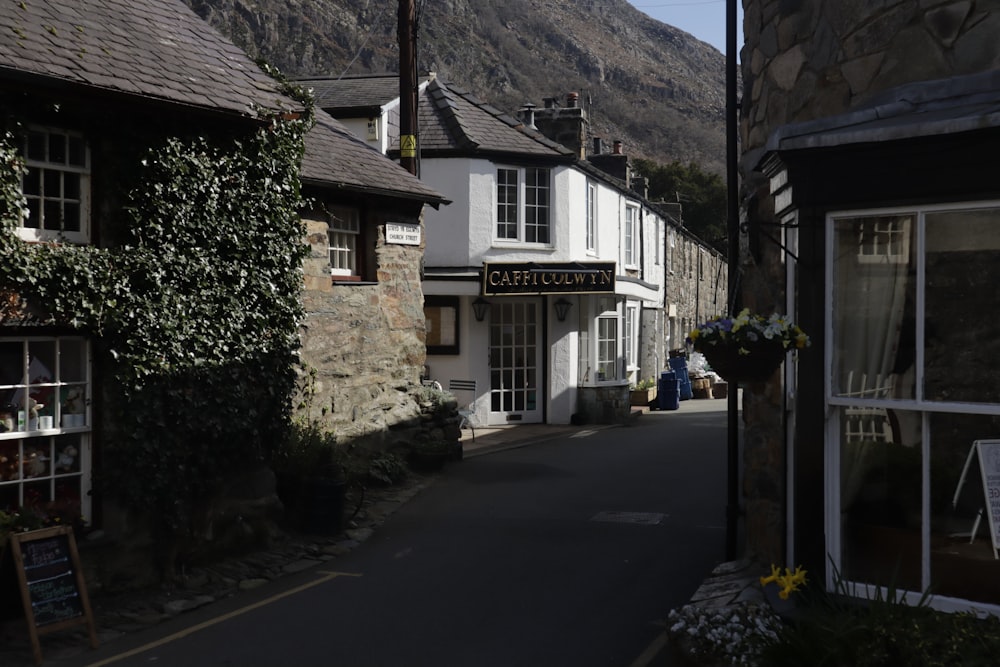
<box><xmin>300</xmin><ymin>76</ymin><xmax>724</xmax><ymax>426</ymax></box>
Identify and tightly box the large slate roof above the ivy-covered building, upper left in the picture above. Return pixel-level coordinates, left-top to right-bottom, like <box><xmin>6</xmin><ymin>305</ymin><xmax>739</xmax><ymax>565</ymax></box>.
<box><xmin>0</xmin><ymin>0</ymin><xmax>299</xmax><ymax>115</ymax></box>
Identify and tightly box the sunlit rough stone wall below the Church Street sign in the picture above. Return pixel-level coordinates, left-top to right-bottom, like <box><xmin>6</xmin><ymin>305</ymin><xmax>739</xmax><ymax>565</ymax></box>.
<box><xmin>302</xmin><ymin>215</ymin><xmax>461</xmax><ymax>448</ymax></box>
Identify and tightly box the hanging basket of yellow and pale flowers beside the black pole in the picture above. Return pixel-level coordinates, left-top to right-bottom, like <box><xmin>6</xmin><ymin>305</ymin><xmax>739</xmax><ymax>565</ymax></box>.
<box><xmin>688</xmin><ymin>308</ymin><xmax>809</xmax><ymax>382</ymax></box>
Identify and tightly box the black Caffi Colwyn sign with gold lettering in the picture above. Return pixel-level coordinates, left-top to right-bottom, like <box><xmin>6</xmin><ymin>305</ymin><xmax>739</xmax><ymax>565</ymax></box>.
<box><xmin>482</xmin><ymin>262</ymin><xmax>615</xmax><ymax>296</ymax></box>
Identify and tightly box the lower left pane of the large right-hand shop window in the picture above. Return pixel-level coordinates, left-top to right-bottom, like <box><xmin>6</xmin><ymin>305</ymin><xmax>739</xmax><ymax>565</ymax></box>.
<box><xmin>840</xmin><ymin>408</ymin><xmax>923</xmax><ymax>591</ymax></box>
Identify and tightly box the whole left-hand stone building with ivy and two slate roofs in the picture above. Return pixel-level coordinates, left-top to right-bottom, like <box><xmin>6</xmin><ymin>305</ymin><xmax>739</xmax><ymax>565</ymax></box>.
<box><xmin>0</xmin><ymin>0</ymin><xmax>448</xmax><ymax>576</ymax></box>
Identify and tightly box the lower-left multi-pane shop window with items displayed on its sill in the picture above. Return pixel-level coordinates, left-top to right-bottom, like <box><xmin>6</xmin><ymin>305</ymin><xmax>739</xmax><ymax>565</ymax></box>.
<box><xmin>0</xmin><ymin>337</ymin><xmax>90</xmax><ymax>517</ymax></box>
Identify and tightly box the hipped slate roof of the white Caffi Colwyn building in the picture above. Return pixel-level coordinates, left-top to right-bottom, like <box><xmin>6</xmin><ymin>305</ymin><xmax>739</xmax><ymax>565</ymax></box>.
<box><xmin>414</xmin><ymin>78</ymin><xmax>576</xmax><ymax>162</ymax></box>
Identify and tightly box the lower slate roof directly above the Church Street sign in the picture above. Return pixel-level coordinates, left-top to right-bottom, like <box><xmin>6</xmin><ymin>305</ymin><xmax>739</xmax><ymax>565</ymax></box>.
<box><xmin>301</xmin><ymin>109</ymin><xmax>448</xmax><ymax>207</ymax></box>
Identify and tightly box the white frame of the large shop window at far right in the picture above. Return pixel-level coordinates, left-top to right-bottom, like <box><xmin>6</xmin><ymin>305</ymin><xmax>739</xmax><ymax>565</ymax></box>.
<box><xmin>823</xmin><ymin>200</ymin><xmax>1000</xmax><ymax>614</ymax></box>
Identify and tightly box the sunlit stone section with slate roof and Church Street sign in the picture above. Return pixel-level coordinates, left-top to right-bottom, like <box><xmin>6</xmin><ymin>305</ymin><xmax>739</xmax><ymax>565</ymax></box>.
<box><xmin>302</xmin><ymin>111</ymin><xmax>450</xmax><ymax>448</ymax></box>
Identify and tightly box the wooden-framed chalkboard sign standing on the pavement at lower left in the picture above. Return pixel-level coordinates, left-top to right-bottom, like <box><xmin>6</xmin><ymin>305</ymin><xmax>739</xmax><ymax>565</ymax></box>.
<box><xmin>10</xmin><ymin>526</ymin><xmax>97</xmax><ymax>664</ymax></box>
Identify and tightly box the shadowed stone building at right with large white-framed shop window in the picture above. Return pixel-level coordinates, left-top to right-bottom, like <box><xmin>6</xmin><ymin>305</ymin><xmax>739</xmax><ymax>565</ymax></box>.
<box><xmin>738</xmin><ymin>0</ymin><xmax>1000</xmax><ymax>611</ymax></box>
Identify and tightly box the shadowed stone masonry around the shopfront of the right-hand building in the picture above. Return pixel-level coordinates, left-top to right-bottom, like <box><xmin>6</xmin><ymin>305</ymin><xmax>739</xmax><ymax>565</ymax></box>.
<box><xmin>739</xmin><ymin>0</ymin><xmax>1000</xmax><ymax>562</ymax></box>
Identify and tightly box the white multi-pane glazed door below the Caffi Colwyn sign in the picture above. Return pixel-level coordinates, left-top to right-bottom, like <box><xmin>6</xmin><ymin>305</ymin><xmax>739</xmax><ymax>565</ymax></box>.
<box><xmin>489</xmin><ymin>299</ymin><xmax>542</xmax><ymax>426</ymax></box>
